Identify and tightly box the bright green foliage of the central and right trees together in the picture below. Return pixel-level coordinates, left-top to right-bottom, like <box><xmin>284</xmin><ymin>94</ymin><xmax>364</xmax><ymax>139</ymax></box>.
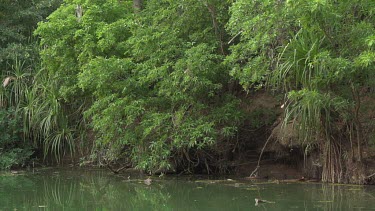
<box><xmin>21</xmin><ymin>0</ymin><xmax>375</xmax><ymax>176</ymax></box>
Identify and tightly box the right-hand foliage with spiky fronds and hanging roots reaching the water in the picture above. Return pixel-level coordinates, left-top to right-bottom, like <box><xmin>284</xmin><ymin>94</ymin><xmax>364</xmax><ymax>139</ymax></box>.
<box><xmin>228</xmin><ymin>0</ymin><xmax>375</xmax><ymax>182</ymax></box>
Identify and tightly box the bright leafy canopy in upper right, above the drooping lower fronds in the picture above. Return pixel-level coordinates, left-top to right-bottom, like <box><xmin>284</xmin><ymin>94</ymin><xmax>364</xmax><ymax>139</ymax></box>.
<box><xmin>227</xmin><ymin>0</ymin><xmax>374</xmax><ymax>88</ymax></box>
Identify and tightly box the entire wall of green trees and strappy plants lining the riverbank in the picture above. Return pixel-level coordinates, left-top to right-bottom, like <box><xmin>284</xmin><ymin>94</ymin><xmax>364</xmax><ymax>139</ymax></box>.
<box><xmin>0</xmin><ymin>0</ymin><xmax>375</xmax><ymax>182</ymax></box>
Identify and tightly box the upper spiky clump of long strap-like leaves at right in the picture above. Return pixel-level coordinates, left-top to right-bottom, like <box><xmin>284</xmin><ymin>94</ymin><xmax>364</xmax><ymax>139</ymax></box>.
<box><xmin>269</xmin><ymin>30</ymin><xmax>351</xmax><ymax>91</ymax></box>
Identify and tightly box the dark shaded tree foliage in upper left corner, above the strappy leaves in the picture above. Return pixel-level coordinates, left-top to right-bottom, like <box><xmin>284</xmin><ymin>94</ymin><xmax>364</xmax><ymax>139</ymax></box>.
<box><xmin>0</xmin><ymin>0</ymin><xmax>59</xmax><ymax>71</ymax></box>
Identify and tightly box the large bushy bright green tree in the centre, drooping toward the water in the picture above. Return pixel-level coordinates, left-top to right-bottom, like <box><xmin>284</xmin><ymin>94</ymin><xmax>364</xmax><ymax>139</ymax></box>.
<box><xmin>33</xmin><ymin>0</ymin><xmax>242</xmax><ymax>171</ymax></box>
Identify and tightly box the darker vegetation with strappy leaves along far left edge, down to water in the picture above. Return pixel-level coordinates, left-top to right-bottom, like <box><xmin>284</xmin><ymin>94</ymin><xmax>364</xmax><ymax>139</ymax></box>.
<box><xmin>0</xmin><ymin>0</ymin><xmax>59</xmax><ymax>169</ymax></box>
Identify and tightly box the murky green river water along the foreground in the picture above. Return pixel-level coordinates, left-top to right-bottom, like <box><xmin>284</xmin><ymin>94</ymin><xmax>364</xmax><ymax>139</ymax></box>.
<box><xmin>0</xmin><ymin>169</ymin><xmax>375</xmax><ymax>210</ymax></box>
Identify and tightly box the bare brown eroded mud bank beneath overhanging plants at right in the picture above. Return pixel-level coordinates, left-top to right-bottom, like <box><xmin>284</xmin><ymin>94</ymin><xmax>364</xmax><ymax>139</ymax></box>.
<box><xmin>234</xmin><ymin>138</ymin><xmax>375</xmax><ymax>185</ymax></box>
